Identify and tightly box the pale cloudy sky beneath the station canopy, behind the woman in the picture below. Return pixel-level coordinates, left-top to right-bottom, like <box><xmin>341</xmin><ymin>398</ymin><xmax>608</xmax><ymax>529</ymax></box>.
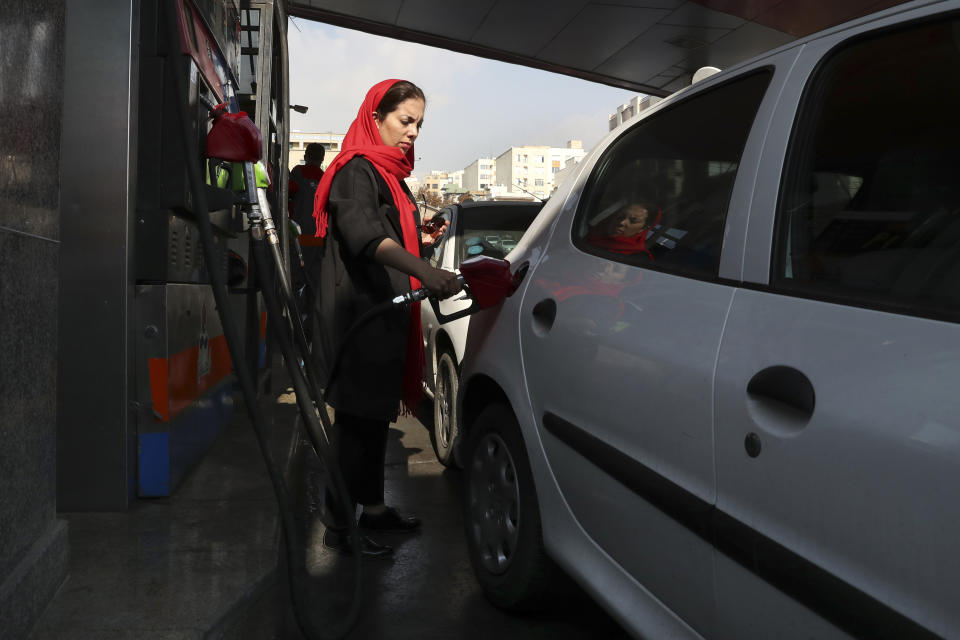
<box><xmin>287</xmin><ymin>18</ymin><xmax>637</xmax><ymax>177</ymax></box>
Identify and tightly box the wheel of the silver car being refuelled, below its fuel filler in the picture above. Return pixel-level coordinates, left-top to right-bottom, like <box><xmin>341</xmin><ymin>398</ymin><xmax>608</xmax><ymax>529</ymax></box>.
<box><xmin>463</xmin><ymin>404</ymin><xmax>569</xmax><ymax>611</ymax></box>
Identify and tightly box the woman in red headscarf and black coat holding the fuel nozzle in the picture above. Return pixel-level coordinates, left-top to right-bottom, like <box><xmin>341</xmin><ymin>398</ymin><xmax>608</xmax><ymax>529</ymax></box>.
<box><xmin>313</xmin><ymin>80</ymin><xmax>460</xmax><ymax>556</ymax></box>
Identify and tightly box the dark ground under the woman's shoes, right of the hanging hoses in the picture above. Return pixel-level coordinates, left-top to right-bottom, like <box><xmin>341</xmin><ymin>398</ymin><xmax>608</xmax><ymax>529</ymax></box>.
<box><xmin>284</xmin><ymin>402</ymin><xmax>627</xmax><ymax>640</ymax></box>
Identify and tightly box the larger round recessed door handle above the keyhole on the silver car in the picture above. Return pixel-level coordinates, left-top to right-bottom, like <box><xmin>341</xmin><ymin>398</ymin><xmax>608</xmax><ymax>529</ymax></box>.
<box><xmin>747</xmin><ymin>365</ymin><xmax>817</xmax><ymax>436</ymax></box>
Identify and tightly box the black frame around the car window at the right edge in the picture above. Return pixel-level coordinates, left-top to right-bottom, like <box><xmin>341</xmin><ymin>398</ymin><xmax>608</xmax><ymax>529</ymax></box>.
<box><xmin>768</xmin><ymin>10</ymin><xmax>960</xmax><ymax>323</ymax></box>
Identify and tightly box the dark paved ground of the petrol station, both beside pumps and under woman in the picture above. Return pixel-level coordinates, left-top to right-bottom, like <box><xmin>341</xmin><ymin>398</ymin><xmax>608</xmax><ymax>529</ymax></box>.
<box><xmin>24</xmin><ymin>362</ymin><xmax>627</xmax><ymax>640</ymax></box>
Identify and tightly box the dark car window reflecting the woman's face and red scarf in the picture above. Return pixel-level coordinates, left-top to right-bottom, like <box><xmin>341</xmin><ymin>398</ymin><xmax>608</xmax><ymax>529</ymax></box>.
<box><xmin>573</xmin><ymin>69</ymin><xmax>771</xmax><ymax>276</ymax></box>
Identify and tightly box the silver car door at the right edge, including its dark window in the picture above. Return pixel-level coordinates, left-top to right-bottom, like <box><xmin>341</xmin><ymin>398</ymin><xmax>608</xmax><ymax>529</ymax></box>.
<box><xmin>714</xmin><ymin>10</ymin><xmax>960</xmax><ymax>638</ymax></box>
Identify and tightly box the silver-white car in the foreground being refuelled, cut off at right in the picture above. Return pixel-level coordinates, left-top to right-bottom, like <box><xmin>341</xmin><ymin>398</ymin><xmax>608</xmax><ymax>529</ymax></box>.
<box><xmin>456</xmin><ymin>1</ymin><xmax>960</xmax><ymax>640</ymax></box>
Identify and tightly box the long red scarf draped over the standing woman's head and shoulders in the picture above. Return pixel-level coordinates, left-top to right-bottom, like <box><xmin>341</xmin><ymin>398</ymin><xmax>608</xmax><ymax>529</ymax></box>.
<box><xmin>313</xmin><ymin>80</ymin><xmax>426</xmax><ymax>414</ymax></box>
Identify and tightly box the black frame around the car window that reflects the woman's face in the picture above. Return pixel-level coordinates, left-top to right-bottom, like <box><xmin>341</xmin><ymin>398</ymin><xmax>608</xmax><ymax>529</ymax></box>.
<box><xmin>568</xmin><ymin>63</ymin><xmax>777</xmax><ymax>285</ymax></box>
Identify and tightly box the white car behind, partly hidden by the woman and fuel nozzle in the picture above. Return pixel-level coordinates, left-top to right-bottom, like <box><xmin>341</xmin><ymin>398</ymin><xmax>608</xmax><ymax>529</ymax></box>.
<box><xmin>420</xmin><ymin>202</ymin><xmax>543</xmax><ymax>465</ymax></box>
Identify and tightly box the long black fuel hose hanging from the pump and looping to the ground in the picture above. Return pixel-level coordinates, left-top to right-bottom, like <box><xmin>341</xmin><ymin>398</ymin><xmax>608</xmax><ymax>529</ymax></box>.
<box><xmin>161</xmin><ymin>1</ymin><xmax>362</xmax><ymax>640</ymax></box>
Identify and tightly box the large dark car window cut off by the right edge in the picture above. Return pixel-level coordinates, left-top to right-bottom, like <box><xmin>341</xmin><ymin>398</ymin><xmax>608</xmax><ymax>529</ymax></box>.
<box><xmin>772</xmin><ymin>20</ymin><xmax>960</xmax><ymax>315</ymax></box>
